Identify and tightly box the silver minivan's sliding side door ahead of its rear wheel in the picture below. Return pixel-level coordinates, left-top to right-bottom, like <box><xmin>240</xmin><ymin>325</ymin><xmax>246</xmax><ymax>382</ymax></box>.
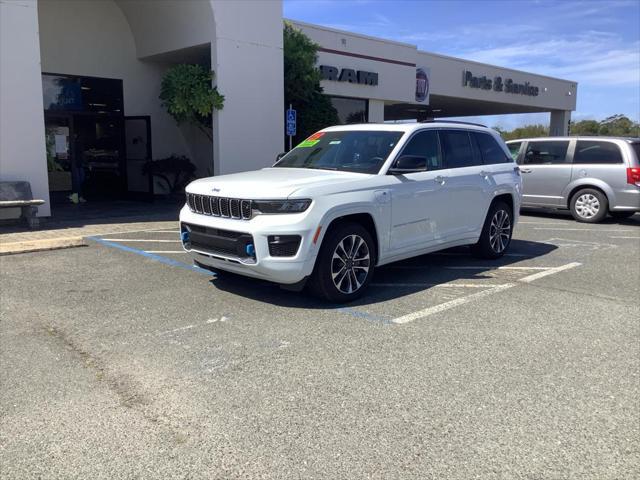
<box><xmin>520</xmin><ymin>140</ymin><xmax>573</xmax><ymax>207</ymax></box>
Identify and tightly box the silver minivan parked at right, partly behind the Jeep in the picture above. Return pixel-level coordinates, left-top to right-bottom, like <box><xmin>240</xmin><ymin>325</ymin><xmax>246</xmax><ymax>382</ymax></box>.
<box><xmin>507</xmin><ymin>137</ymin><xmax>640</xmax><ymax>223</ymax></box>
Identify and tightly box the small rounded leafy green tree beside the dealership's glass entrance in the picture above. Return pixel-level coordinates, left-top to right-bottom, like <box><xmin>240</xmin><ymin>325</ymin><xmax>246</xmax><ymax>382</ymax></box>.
<box><xmin>160</xmin><ymin>64</ymin><xmax>224</xmax><ymax>140</ymax></box>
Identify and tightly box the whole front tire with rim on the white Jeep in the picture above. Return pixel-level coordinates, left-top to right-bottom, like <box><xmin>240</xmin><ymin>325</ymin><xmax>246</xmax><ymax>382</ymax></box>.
<box><xmin>309</xmin><ymin>222</ymin><xmax>376</xmax><ymax>303</ymax></box>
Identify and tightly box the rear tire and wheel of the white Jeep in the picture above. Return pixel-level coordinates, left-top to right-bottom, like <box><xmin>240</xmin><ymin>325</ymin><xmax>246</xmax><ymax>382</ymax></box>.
<box><xmin>471</xmin><ymin>201</ymin><xmax>513</xmax><ymax>259</ymax></box>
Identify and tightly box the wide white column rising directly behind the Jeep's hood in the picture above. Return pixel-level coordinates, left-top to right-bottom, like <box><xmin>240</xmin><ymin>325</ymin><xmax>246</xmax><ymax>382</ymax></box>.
<box><xmin>211</xmin><ymin>0</ymin><xmax>284</xmax><ymax>175</ymax></box>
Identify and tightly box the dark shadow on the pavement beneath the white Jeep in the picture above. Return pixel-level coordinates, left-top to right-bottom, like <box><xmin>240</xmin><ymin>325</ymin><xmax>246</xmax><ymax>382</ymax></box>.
<box><xmin>211</xmin><ymin>239</ymin><xmax>558</xmax><ymax>310</ymax></box>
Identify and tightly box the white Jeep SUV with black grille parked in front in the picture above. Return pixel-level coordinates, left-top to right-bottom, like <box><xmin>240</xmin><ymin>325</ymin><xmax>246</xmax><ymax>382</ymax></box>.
<box><xmin>180</xmin><ymin>121</ymin><xmax>521</xmax><ymax>302</ymax></box>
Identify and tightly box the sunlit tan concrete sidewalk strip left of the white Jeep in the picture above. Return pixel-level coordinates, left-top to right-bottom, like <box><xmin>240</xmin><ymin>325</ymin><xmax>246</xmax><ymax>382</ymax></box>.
<box><xmin>0</xmin><ymin>219</ymin><xmax>178</xmax><ymax>255</ymax></box>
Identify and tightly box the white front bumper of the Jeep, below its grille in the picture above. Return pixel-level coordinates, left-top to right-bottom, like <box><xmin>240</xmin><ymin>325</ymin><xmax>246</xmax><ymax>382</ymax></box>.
<box><xmin>180</xmin><ymin>206</ymin><xmax>317</xmax><ymax>285</ymax></box>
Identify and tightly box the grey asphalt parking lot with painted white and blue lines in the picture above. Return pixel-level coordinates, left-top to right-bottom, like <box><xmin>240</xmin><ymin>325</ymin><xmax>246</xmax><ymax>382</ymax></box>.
<box><xmin>0</xmin><ymin>212</ymin><xmax>640</xmax><ymax>479</ymax></box>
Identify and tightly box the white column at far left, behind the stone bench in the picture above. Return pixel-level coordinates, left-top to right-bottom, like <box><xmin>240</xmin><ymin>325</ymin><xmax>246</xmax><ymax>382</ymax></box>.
<box><xmin>0</xmin><ymin>0</ymin><xmax>51</xmax><ymax>216</ymax></box>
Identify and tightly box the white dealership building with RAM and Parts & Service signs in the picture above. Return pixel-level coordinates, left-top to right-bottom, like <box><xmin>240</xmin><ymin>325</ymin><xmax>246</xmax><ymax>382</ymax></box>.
<box><xmin>0</xmin><ymin>0</ymin><xmax>577</xmax><ymax>216</ymax></box>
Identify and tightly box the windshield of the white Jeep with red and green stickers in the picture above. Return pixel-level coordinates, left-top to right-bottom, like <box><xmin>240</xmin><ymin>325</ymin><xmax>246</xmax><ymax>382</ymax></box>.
<box><xmin>274</xmin><ymin>130</ymin><xmax>403</xmax><ymax>174</ymax></box>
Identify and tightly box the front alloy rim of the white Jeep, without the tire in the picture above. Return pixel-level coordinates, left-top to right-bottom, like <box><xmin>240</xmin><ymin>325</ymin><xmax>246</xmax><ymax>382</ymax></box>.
<box><xmin>331</xmin><ymin>235</ymin><xmax>371</xmax><ymax>294</ymax></box>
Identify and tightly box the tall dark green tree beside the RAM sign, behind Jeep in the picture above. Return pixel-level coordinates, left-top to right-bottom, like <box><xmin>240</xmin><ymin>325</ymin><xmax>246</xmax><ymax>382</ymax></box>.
<box><xmin>283</xmin><ymin>22</ymin><xmax>340</xmax><ymax>143</ymax></box>
